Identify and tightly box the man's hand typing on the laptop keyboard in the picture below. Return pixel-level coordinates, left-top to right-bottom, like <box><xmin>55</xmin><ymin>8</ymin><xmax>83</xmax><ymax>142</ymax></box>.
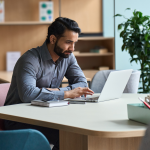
<box><xmin>64</xmin><ymin>87</ymin><xmax>94</xmax><ymax>98</ymax></box>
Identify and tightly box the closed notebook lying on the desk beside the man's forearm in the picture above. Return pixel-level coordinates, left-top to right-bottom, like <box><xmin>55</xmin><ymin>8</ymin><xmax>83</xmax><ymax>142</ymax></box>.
<box><xmin>31</xmin><ymin>100</ymin><xmax>69</xmax><ymax>107</ymax></box>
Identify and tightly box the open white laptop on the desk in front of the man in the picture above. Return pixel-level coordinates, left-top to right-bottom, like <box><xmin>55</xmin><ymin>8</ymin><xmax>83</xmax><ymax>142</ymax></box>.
<box><xmin>66</xmin><ymin>69</ymin><xmax>133</xmax><ymax>102</ymax></box>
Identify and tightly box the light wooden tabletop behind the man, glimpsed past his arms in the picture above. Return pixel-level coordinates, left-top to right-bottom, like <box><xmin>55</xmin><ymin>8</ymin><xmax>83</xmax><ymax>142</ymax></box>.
<box><xmin>0</xmin><ymin>71</ymin><xmax>91</xmax><ymax>83</ymax></box>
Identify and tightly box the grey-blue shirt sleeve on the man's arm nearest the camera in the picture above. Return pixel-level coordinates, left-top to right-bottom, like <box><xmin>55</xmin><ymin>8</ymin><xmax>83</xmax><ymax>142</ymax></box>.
<box><xmin>16</xmin><ymin>53</ymin><xmax>64</xmax><ymax>103</ymax></box>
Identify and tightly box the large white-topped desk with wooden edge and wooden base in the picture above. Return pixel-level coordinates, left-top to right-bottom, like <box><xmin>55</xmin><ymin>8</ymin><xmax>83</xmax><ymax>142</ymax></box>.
<box><xmin>0</xmin><ymin>94</ymin><xmax>147</xmax><ymax>150</ymax></box>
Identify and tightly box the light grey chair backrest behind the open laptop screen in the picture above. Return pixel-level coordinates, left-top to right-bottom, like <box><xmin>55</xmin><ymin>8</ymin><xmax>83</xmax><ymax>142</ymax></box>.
<box><xmin>91</xmin><ymin>70</ymin><xmax>140</xmax><ymax>93</ymax></box>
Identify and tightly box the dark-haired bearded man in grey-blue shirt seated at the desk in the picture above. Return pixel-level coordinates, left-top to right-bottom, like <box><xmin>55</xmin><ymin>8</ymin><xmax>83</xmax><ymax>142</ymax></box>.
<box><xmin>5</xmin><ymin>17</ymin><xmax>93</xmax><ymax>150</ymax></box>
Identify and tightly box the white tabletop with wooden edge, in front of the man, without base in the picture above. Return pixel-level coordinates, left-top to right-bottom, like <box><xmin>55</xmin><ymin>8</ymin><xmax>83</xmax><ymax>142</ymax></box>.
<box><xmin>0</xmin><ymin>94</ymin><xmax>147</xmax><ymax>138</ymax></box>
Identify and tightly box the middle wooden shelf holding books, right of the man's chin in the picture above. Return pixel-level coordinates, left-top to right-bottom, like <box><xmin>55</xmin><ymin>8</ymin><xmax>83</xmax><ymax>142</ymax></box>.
<box><xmin>74</xmin><ymin>53</ymin><xmax>113</xmax><ymax>57</ymax></box>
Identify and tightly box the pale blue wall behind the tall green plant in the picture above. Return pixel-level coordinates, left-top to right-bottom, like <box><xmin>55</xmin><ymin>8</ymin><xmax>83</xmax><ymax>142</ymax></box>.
<box><xmin>103</xmin><ymin>0</ymin><xmax>150</xmax><ymax>70</ymax></box>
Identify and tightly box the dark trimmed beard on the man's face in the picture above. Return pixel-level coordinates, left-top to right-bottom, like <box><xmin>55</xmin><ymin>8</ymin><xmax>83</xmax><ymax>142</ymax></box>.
<box><xmin>54</xmin><ymin>42</ymin><xmax>72</xmax><ymax>58</ymax></box>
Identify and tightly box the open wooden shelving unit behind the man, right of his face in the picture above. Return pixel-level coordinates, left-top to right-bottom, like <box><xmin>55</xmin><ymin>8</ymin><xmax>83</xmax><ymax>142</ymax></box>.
<box><xmin>75</xmin><ymin>37</ymin><xmax>115</xmax><ymax>78</ymax></box>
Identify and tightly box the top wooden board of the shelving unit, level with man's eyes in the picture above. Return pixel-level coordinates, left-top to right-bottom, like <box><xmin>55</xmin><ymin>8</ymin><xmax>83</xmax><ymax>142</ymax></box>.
<box><xmin>78</xmin><ymin>36</ymin><xmax>114</xmax><ymax>41</ymax></box>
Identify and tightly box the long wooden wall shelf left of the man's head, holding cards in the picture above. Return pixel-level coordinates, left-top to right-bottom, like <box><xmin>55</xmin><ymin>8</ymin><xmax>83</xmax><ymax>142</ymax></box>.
<box><xmin>0</xmin><ymin>21</ymin><xmax>52</xmax><ymax>25</ymax></box>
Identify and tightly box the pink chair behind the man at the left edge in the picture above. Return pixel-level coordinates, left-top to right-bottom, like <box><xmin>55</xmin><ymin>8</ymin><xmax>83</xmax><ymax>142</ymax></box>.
<box><xmin>0</xmin><ymin>83</ymin><xmax>10</xmax><ymax>130</ymax></box>
